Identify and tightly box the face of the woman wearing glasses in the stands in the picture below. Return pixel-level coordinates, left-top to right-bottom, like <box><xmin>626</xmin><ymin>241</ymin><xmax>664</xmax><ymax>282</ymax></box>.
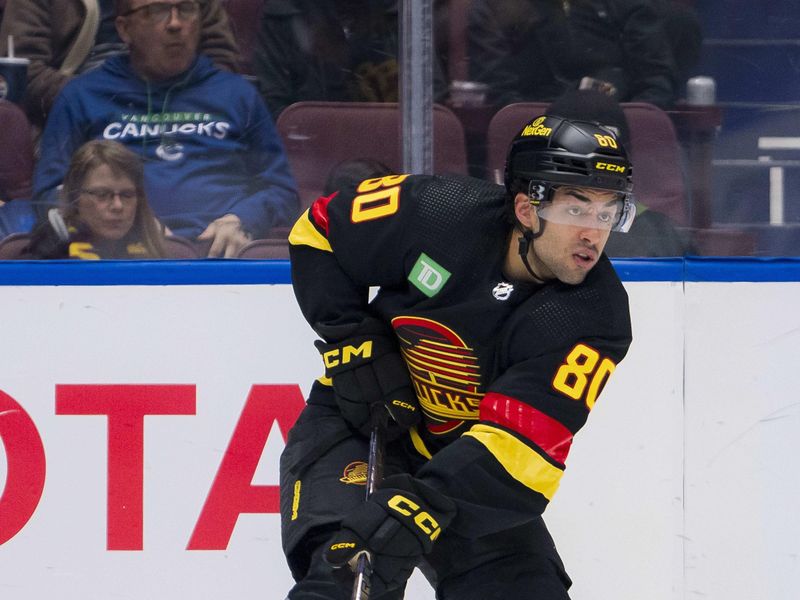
<box><xmin>78</xmin><ymin>165</ymin><xmax>138</xmax><ymax>240</ymax></box>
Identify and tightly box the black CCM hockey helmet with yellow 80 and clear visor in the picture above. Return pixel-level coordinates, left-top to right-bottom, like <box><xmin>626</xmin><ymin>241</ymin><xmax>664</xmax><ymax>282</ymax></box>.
<box><xmin>505</xmin><ymin>115</ymin><xmax>636</xmax><ymax>231</ymax></box>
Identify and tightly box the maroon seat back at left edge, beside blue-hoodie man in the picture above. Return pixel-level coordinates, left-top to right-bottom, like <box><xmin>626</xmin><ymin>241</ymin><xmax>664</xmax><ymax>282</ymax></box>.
<box><xmin>0</xmin><ymin>99</ymin><xmax>34</xmax><ymax>201</ymax></box>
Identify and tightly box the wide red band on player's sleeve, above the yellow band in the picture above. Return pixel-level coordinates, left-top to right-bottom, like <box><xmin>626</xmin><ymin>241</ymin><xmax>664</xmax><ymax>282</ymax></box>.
<box><xmin>480</xmin><ymin>392</ymin><xmax>572</xmax><ymax>465</ymax></box>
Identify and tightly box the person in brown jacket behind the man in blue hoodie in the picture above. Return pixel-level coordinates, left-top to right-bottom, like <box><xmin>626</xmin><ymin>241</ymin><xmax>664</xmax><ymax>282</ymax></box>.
<box><xmin>0</xmin><ymin>0</ymin><xmax>238</xmax><ymax>128</ymax></box>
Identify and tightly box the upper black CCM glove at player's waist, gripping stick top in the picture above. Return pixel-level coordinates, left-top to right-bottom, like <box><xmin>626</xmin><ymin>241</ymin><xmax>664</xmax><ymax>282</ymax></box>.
<box><xmin>314</xmin><ymin>335</ymin><xmax>420</xmax><ymax>439</ymax></box>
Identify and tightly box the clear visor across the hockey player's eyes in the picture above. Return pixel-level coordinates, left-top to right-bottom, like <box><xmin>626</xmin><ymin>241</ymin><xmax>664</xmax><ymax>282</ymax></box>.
<box><xmin>536</xmin><ymin>195</ymin><xmax>636</xmax><ymax>232</ymax></box>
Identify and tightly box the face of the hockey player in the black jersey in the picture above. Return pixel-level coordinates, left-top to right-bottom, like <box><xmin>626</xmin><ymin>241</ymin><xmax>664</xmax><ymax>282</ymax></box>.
<box><xmin>530</xmin><ymin>186</ymin><xmax>621</xmax><ymax>284</ymax></box>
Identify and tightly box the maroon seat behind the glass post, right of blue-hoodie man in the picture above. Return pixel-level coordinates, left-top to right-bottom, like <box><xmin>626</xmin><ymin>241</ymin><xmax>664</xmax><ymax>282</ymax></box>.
<box><xmin>277</xmin><ymin>102</ymin><xmax>467</xmax><ymax>209</ymax></box>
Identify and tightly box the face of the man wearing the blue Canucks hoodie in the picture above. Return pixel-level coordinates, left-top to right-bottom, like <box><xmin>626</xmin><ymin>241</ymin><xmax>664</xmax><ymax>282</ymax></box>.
<box><xmin>116</xmin><ymin>0</ymin><xmax>200</xmax><ymax>81</ymax></box>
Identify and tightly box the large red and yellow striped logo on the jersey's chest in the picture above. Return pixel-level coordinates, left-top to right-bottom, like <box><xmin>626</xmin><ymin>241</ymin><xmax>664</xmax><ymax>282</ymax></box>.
<box><xmin>392</xmin><ymin>317</ymin><xmax>483</xmax><ymax>435</ymax></box>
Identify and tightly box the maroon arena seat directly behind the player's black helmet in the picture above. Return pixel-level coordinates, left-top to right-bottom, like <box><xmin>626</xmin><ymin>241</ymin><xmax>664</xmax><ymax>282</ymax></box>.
<box><xmin>487</xmin><ymin>102</ymin><xmax>688</xmax><ymax>225</ymax></box>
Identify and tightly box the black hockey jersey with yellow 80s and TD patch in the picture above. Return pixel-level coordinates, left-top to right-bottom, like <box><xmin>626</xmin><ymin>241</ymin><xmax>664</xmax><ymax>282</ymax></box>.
<box><xmin>289</xmin><ymin>175</ymin><xmax>631</xmax><ymax>537</ymax></box>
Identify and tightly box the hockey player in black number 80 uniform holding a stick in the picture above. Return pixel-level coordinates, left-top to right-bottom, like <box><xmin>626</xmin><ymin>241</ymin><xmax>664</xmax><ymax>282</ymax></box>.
<box><xmin>281</xmin><ymin>116</ymin><xmax>635</xmax><ymax>600</ymax></box>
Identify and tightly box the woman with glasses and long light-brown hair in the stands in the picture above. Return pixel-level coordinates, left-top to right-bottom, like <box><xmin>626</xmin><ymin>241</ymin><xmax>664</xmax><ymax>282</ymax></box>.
<box><xmin>25</xmin><ymin>140</ymin><xmax>164</xmax><ymax>259</ymax></box>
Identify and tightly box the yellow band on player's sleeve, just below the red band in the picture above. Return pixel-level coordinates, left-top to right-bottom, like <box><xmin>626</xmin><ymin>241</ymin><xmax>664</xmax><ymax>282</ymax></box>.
<box><xmin>464</xmin><ymin>424</ymin><xmax>564</xmax><ymax>500</ymax></box>
